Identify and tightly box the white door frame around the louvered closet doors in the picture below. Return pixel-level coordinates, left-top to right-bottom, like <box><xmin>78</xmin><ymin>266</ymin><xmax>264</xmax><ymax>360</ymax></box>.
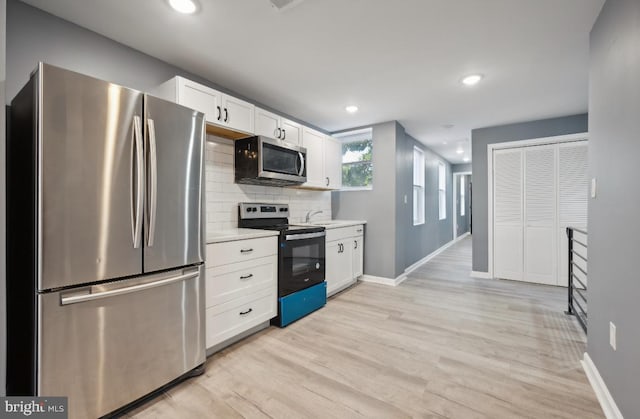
<box><xmin>490</xmin><ymin>132</ymin><xmax>589</xmax><ymax>279</ymax></box>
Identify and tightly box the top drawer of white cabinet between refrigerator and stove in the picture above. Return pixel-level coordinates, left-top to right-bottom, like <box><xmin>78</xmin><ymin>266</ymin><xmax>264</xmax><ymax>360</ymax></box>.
<box><xmin>207</xmin><ymin>236</ymin><xmax>278</xmax><ymax>267</ymax></box>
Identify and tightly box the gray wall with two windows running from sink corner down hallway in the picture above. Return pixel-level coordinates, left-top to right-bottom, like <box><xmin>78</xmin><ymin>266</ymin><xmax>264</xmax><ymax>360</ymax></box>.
<box><xmin>331</xmin><ymin>121</ymin><xmax>453</xmax><ymax>278</ymax></box>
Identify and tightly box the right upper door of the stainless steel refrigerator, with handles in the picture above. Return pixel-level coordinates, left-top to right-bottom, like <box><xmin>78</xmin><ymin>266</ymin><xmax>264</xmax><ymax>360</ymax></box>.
<box><xmin>144</xmin><ymin>96</ymin><xmax>204</xmax><ymax>272</ymax></box>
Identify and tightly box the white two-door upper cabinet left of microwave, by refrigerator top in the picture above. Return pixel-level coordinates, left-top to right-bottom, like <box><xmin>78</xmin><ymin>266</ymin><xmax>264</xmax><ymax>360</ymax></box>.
<box><xmin>154</xmin><ymin>76</ymin><xmax>255</xmax><ymax>134</ymax></box>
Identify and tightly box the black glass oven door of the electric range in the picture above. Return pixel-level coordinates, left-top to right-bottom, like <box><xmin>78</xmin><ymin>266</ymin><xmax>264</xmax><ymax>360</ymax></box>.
<box><xmin>279</xmin><ymin>237</ymin><xmax>325</xmax><ymax>296</ymax></box>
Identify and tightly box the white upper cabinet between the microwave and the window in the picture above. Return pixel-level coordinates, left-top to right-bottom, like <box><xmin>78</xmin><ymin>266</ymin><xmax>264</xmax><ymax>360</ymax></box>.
<box><xmin>302</xmin><ymin>127</ymin><xmax>342</xmax><ymax>189</ymax></box>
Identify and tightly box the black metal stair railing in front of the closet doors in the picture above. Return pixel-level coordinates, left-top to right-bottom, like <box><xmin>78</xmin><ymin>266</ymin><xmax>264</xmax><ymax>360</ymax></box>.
<box><xmin>565</xmin><ymin>227</ymin><xmax>587</xmax><ymax>333</ymax></box>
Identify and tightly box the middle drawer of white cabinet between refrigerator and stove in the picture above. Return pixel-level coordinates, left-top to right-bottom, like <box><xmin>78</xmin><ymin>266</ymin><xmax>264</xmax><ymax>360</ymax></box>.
<box><xmin>206</xmin><ymin>255</ymin><xmax>278</xmax><ymax>308</ymax></box>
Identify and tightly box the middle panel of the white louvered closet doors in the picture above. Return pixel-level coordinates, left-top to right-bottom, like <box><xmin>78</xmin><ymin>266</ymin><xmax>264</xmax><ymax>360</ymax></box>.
<box><xmin>524</xmin><ymin>144</ymin><xmax>558</xmax><ymax>285</ymax></box>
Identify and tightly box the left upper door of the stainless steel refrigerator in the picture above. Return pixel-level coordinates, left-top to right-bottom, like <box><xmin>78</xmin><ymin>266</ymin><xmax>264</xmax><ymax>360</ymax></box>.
<box><xmin>38</xmin><ymin>64</ymin><xmax>143</xmax><ymax>289</ymax></box>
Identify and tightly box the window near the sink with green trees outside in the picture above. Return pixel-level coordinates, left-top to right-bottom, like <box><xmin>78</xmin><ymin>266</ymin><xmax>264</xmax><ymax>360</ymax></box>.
<box><xmin>334</xmin><ymin>128</ymin><xmax>373</xmax><ymax>190</ymax></box>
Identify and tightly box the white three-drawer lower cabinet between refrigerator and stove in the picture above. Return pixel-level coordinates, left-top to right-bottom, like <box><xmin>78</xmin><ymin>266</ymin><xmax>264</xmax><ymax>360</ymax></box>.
<box><xmin>205</xmin><ymin>237</ymin><xmax>278</xmax><ymax>349</ymax></box>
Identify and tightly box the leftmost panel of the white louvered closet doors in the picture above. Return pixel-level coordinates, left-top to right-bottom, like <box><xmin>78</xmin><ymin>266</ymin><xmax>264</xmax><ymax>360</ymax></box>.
<box><xmin>493</xmin><ymin>149</ymin><xmax>523</xmax><ymax>280</ymax></box>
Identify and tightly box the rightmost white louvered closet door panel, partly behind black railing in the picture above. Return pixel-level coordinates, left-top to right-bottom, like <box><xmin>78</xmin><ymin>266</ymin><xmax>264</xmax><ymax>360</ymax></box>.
<box><xmin>557</xmin><ymin>141</ymin><xmax>589</xmax><ymax>287</ymax></box>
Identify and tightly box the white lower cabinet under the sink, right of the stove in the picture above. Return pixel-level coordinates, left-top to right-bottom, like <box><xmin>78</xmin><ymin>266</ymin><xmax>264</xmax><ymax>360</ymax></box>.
<box><xmin>325</xmin><ymin>225</ymin><xmax>364</xmax><ymax>296</ymax></box>
